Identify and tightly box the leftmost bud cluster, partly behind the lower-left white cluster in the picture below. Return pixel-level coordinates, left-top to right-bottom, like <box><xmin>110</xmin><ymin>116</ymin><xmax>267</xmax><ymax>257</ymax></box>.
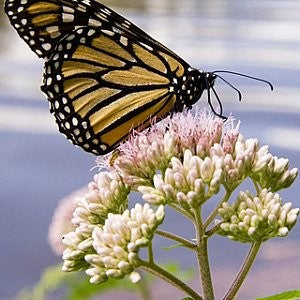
<box><xmin>63</xmin><ymin>172</ymin><xmax>129</xmax><ymax>271</ymax></box>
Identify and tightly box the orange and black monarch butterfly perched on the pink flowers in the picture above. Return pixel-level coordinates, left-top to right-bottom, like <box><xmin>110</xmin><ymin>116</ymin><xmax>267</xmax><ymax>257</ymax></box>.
<box><xmin>5</xmin><ymin>0</ymin><xmax>272</xmax><ymax>155</ymax></box>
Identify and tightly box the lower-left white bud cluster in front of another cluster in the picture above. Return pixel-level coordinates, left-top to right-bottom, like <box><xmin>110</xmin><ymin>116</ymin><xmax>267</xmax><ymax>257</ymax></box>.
<box><xmin>85</xmin><ymin>203</ymin><xmax>164</xmax><ymax>283</ymax></box>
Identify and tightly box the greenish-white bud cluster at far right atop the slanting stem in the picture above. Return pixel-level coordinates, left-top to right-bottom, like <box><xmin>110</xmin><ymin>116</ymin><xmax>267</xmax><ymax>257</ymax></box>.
<box><xmin>219</xmin><ymin>189</ymin><xmax>299</xmax><ymax>243</ymax></box>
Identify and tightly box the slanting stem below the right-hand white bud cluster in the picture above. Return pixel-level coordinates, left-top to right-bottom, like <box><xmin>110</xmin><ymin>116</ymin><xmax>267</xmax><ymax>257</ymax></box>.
<box><xmin>223</xmin><ymin>242</ymin><xmax>261</xmax><ymax>300</ymax></box>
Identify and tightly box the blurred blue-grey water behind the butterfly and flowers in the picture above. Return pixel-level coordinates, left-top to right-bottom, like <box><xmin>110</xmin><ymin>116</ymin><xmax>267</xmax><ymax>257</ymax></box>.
<box><xmin>0</xmin><ymin>0</ymin><xmax>300</xmax><ymax>299</ymax></box>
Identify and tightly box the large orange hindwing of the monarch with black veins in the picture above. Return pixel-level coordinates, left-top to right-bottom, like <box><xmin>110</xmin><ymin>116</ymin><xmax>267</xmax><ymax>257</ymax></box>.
<box><xmin>42</xmin><ymin>26</ymin><xmax>186</xmax><ymax>154</ymax></box>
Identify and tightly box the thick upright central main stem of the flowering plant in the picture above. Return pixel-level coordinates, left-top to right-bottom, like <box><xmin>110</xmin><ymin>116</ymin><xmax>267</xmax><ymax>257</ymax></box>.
<box><xmin>194</xmin><ymin>208</ymin><xmax>214</xmax><ymax>300</ymax></box>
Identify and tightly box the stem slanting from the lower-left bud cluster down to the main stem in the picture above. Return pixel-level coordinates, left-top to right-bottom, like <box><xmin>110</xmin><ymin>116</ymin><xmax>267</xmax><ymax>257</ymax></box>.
<box><xmin>141</xmin><ymin>260</ymin><xmax>203</xmax><ymax>300</ymax></box>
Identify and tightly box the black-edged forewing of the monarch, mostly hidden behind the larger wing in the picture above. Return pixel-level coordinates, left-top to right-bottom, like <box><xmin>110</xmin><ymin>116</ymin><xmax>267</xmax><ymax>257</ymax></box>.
<box><xmin>5</xmin><ymin>0</ymin><xmax>180</xmax><ymax>59</ymax></box>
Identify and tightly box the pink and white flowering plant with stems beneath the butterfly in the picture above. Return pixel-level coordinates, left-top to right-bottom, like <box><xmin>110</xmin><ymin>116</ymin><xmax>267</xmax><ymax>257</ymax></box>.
<box><xmin>54</xmin><ymin>111</ymin><xmax>299</xmax><ymax>300</ymax></box>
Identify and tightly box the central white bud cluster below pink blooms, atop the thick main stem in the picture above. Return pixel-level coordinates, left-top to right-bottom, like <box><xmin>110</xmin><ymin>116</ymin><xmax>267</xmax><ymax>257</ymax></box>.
<box><xmin>138</xmin><ymin>150</ymin><xmax>223</xmax><ymax>209</ymax></box>
